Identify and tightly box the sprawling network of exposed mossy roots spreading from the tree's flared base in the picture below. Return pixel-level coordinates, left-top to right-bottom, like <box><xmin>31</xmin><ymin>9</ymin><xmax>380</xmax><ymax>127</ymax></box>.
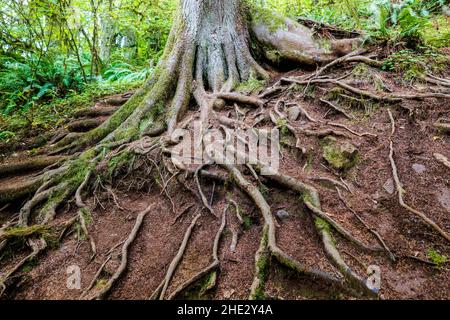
<box><xmin>4</xmin><ymin>1</ymin><xmax>450</xmax><ymax>299</ymax></box>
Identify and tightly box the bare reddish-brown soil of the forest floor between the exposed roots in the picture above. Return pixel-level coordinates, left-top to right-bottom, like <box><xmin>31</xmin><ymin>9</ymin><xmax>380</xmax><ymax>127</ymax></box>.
<box><xmin>0</xmin><ymin>62</ymin><xmax>450</xmax><ymax>299</ymax></box>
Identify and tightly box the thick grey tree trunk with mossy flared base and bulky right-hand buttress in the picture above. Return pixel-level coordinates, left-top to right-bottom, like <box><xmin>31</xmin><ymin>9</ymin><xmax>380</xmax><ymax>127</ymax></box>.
<box><xmin>68</xmin><ymin>0</ymin><xmax>359</xmax><ymax>146</ymax></box>
